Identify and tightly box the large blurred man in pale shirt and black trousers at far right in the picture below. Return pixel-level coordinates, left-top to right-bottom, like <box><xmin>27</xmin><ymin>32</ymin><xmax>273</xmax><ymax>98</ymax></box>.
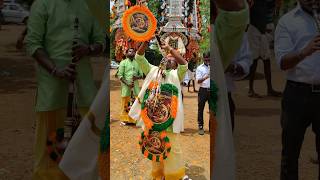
<box><xmin>275</xmin><ymin>0</ymin><xmax>320</xmax><ymax>180</ymax></box>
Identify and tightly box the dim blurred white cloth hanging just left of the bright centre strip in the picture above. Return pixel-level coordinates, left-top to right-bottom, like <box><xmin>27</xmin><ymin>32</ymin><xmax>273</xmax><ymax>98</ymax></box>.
<box><xmin>59</xmin><ymin>66</ymin><xmax>109</xmax><ymax>180</ymax></box>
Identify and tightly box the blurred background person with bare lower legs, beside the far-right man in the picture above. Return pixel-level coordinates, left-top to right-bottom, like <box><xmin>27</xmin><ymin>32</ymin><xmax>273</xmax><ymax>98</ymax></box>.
<box><xmin>248</xmin><ymin>0</ymin><xmax>281</xmax><ymax>98</ymax></box>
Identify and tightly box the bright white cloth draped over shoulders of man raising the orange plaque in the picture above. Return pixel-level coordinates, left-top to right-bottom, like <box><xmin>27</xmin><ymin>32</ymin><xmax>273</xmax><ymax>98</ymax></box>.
<box><xmin>129</xmin><ymin>66</ymin><xmax>184</xmax><ymax>133</ymax></box>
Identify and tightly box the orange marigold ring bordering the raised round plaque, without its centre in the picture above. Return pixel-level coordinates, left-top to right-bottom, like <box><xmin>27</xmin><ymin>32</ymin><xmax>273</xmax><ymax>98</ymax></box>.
<box><xmin>122</xmin><ymin>5</ymin><xmax>157</xmax><ymax>42</ymax></box>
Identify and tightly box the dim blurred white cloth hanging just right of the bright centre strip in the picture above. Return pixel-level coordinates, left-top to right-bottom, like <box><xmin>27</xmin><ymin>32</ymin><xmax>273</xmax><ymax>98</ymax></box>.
<box><xmin>210</xmin><ymin>25</ymin><xmax>235</xmax><ymax>180</ymax></box>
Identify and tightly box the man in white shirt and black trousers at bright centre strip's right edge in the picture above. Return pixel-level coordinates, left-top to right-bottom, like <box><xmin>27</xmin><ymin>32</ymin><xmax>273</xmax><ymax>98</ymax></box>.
<box><xmin>196</xmin><ymin>52</ymin><xmax>210</xmax><ymax>135</ymax></box>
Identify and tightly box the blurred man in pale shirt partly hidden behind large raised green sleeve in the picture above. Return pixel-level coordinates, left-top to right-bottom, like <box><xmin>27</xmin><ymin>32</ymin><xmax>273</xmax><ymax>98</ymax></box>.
<box><xmin>225</xmin><ymin>33</ymin><xmax>252</xmax><ymax>131</ymax></box>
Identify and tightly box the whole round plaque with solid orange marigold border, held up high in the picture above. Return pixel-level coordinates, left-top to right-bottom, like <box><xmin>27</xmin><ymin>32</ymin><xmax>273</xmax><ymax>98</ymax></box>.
<box><xmin>122</xmin><ymin>5</ymin><xmax>157</xmax><ymax>42</ymax></box>
